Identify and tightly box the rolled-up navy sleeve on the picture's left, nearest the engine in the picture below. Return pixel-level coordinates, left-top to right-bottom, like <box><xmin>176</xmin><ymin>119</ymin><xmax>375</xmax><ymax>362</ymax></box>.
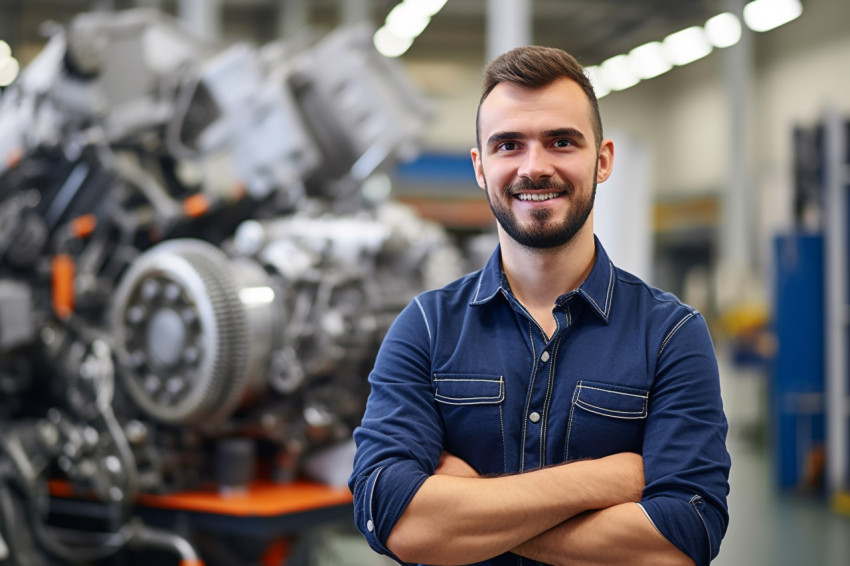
<box><xmin>348</xmin><ymin>299</ymin><xmax>443</xmax><ymax>558</ymax></box>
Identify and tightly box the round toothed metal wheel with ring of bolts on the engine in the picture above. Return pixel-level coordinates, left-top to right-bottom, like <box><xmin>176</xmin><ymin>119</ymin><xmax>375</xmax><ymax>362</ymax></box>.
<box><xmin>112</xmin><ymin>239</ymin><xmax>253</xmax><ymax>430</ymax></box>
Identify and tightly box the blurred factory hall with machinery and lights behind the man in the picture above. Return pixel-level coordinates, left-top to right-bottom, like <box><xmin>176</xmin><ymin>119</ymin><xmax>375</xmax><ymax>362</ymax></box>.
<box><xmin>0</xmin><ymin>0</ymin><xmax>850</xmax><ymax>566</ymax></box>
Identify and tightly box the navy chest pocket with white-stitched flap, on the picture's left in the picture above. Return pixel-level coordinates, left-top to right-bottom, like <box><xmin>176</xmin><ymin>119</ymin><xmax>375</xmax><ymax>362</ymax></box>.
<box><xmin>434</xmin><ymin>374</ymin><xmax>505</xmax><ymax>474</ymax></box>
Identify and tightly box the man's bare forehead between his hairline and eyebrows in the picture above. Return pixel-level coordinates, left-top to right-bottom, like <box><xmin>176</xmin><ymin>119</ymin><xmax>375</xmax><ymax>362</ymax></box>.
<box><xmin>479</xmin><ymin>78</ymin><xmax>593</xmax><ymax>141</ymax></box>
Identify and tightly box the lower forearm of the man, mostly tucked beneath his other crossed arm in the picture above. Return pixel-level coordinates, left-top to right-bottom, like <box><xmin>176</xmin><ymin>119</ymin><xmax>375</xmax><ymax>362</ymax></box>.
<box><xmin>513</xmin><ymin>503</ymin><xmax>693</xmax><ymax>566</ymax></box>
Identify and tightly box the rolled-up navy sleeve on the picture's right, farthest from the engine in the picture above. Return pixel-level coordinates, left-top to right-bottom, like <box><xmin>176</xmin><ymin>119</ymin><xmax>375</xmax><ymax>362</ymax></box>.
<box><xmin>641</xmin><ymin>311</ymin><xmax>731</xmax><ymax>566</ymax></box>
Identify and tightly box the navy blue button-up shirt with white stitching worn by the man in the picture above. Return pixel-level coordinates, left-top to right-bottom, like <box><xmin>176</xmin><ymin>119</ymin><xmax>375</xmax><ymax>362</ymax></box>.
<box><xmin>349</xmin><ymin>240</ymin><xmax>730</xmax><ymax>566</ymax></box>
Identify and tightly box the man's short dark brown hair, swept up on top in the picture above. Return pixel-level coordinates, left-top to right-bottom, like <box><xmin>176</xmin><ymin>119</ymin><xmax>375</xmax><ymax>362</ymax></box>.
<box><xmin>475</xmin><ymin>45</ymin><xmax>602</xmax><ymax>149</ymax></box>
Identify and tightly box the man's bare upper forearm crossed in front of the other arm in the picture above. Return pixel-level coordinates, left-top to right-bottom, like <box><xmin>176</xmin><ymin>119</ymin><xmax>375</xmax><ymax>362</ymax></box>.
<box><xmin>386</xmin><ymin>454</ymin><xmax>642</xmax><ymax>564</ymax></box>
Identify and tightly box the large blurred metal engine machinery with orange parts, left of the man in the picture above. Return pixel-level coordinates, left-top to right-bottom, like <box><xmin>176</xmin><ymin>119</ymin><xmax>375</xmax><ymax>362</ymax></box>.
<box><xmin>0</xmin><ymin>10</ymin><xmax>461</xmax><ymax>566</ymax></box>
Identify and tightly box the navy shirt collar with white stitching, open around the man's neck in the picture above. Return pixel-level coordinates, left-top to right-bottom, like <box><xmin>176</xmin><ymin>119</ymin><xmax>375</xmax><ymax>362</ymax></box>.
<box><xmin>469</xmin><ymin>235</ymin><xmax>615</xmax><ymax>323</ymax></box>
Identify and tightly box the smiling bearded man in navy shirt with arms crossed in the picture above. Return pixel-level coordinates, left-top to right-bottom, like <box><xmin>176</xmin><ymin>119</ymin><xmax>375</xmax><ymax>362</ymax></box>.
<box><xmin>349</xmin><ymin>47</ymin><xmax>730</xmax><ymax>566</ymax></box>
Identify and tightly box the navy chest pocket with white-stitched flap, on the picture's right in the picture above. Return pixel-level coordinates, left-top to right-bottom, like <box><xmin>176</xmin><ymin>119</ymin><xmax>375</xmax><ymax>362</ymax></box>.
<box><xmin>565</xmin><ymin>381</ymin><xmax>649</xmax><ymax>460</ymax></box>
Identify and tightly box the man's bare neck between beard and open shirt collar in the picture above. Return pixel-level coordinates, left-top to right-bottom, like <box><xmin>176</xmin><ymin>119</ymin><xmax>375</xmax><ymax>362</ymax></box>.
<box><xmin>499</xmin><ymin>226</ymin><xmax>596</xmax><ymax>336</ymax></box>
